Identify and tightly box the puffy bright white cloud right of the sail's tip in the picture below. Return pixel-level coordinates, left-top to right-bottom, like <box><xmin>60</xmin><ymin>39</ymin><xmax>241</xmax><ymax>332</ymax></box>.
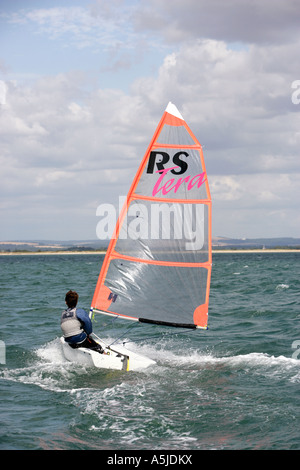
<box><xmin>134</xmin><ymin>40</ymin><xmax>299</xmax><ymax>162</ymax></box>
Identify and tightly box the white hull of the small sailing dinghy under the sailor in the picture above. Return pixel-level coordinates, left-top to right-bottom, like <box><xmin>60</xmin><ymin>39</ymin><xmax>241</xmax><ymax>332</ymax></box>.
<box><xmin>60</xmin><ymin>337</ymin><xmax>155</xmax><ymax>371</ymax></box>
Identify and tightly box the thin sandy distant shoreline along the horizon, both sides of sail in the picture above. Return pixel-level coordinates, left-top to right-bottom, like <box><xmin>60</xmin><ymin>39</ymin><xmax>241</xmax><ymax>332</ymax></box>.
<box><xmin>0</xmin><ymin>248</ymin><xmax>300</xmax><ymax>256</ymax></box>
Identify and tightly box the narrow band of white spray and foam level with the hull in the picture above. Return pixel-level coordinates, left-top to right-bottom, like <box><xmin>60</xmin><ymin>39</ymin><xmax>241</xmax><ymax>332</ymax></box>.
<box><xmin>1</xmin><ymin>338</ymin><xmax>300</xmax><ymax>398</ymax></box>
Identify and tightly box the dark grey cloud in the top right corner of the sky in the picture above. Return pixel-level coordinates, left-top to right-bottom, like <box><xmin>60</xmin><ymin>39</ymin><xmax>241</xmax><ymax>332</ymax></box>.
<box><xmin>135</xmin><ymin>0</ymin><xmax>300</xmax><ymax>44</ymax></box>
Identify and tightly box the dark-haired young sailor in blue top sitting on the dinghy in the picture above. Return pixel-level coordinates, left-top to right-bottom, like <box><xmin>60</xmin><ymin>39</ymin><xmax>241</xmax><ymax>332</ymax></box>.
<box><xmin>60</xmin><ymin>290</ymin><xmax>104</xmax><ymax>354</ymax></box>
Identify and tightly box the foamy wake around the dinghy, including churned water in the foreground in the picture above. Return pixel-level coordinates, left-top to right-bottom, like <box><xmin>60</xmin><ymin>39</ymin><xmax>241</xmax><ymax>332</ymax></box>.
<box><xmin>2</xmin><ymin>338</ymin><xmax>300</xmax><ymax>450</ymax></box>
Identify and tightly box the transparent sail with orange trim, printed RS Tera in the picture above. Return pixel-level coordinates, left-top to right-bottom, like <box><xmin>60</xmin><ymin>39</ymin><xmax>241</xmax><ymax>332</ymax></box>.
<box><xmin>91</xmin><ymin>103</ymin><xmax>212</xmax><ymax>328</ymax></box>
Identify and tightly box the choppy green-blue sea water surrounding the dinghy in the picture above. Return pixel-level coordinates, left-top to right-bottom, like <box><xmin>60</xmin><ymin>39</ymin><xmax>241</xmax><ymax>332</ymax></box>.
<box><xmin>0</xmin><ymin>252</ymin><xmax>300</xmax><ymax>451</ymax></box>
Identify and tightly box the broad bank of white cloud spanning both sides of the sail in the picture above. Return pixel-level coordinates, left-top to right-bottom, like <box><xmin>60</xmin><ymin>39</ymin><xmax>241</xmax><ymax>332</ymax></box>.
<box><xmin>1</xmin><ymin>35</ymin><xmax>300</xmax><ymax>236</ymax></box>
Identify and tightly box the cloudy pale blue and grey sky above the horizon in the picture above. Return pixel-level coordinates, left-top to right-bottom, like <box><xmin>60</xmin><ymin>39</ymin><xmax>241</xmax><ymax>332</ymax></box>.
<box><xmin>0</xmin><ymin>0</ymin><xmax>300</xmax><ymax>241</ymax></box>
